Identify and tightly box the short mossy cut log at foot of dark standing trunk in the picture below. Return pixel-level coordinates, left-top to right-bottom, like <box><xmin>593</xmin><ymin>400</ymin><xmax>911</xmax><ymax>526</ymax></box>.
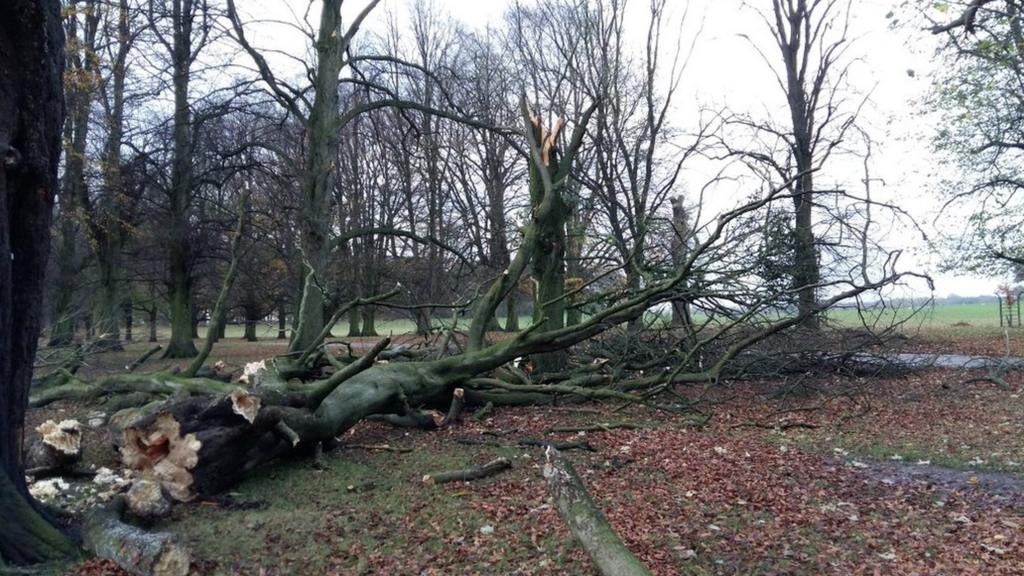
<box><xmin>82</xmin><ymin>496</ymin><xmax>190</xmax><ymax>576</ymax></box>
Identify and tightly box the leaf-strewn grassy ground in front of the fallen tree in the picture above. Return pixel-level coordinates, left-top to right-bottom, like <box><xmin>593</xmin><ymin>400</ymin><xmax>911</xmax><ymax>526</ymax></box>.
<box><xmin>30</xmin><ymin>327</ymin><xmax>1024</xmax><ymax>576</ymax></box>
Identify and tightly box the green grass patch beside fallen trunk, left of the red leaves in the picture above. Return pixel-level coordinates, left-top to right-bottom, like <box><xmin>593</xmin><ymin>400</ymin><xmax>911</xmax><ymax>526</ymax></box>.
<box><xmin>159</xmin><ymin>443</ymin><xmax>568</xmax><ymax>575</ymax></box>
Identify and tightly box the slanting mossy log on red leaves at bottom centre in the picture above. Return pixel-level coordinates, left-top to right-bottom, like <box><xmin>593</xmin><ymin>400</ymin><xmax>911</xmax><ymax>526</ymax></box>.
<box><xmin>544</xmin><ymin>447</ymin><xmax>651</xmax><ymax>576</ymax></box>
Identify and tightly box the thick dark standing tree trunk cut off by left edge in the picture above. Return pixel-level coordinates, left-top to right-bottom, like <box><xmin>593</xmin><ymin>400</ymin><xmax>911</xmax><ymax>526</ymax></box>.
<box><xmin>0</xmin><ymin>0</ymin><xmax>75</xmax><ymax>565</ymax></box>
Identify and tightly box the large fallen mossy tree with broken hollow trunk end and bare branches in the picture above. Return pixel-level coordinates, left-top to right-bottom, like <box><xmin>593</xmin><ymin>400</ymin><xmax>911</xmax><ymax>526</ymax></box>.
<box><xmin>33</xmin><ymin>105</ymin><xmax>917</xmax><ymax>500</ymax></box>
